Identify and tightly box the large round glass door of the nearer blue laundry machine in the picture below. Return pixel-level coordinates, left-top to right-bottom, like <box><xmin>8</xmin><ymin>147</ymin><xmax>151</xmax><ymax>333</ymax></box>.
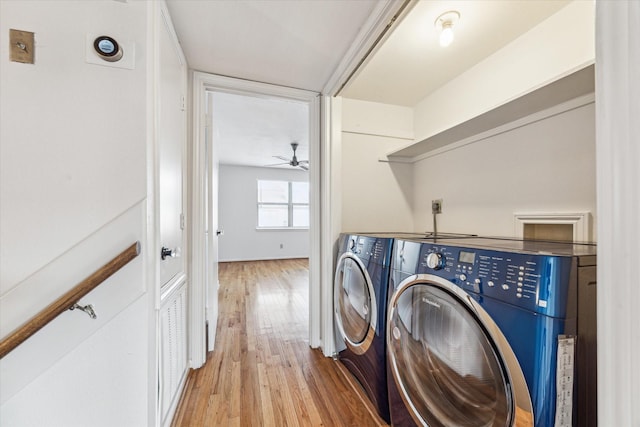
<box><xmin>387</xmin><ymin>275</ymin><xmax>533</xmax><ymax>427</ymax></box>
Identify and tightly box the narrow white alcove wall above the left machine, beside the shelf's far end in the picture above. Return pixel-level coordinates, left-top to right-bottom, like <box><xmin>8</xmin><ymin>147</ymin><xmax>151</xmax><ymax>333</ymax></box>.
<box><xmin>341</xmin><ymin>98</ymin><xmax>413</xmax><ymax>232</ymax></box>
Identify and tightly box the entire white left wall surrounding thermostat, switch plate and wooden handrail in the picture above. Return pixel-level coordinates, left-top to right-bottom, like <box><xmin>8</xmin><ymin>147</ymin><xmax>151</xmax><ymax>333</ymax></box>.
<box><xmin>0</xmin><ymin>0</ymin><xmax>155</xmax><ymax>426</ymax></box>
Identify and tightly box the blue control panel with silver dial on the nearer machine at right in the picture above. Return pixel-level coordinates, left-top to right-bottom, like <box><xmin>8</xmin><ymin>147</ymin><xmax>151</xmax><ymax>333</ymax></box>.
<box><xmin>416</xmin><ymin>243</ymin><xmax>573</xmax><ymax>317</ymax></box>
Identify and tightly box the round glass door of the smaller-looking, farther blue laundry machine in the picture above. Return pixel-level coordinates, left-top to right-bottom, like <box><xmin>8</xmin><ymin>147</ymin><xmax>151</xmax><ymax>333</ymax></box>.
<box><xmin>333</xmin><ymin>252</ymin><xmax>377</xmax><ymax>354</ymax></box>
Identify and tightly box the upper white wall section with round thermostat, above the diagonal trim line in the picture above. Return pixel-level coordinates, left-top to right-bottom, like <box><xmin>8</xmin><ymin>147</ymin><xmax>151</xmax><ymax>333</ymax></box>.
<box><xmin>0</xmin><ymin>1</ymin><xmax>147</xmax><ymax>294</ymax></box>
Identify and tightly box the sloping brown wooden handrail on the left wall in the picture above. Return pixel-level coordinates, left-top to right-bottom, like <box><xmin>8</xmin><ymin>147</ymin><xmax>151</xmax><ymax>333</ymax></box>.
<box><xmin>0</xmin><ymin>242</ymin><xmax>140</xmax><ymax>359</ymax></box>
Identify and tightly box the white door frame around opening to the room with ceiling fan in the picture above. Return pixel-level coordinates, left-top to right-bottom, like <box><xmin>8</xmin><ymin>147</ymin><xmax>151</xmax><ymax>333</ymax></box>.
<box><xmin>189</xmin><ymin>71</ymin><xmax>322</xmax><ymax>368</ymax></box>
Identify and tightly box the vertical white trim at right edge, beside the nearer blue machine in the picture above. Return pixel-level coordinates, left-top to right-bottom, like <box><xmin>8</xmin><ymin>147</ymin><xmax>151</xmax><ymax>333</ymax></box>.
<box><xmin>595</xmin><ymin>1</ymin><xmax>640</xmax><ymax>427</ymax></box>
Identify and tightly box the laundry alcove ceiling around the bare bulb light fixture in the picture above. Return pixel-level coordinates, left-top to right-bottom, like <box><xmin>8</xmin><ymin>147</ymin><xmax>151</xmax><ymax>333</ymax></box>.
<box><xmin>341</xmin><ymin>0</ymin><xmax>569</xmax><ymax>107</ymax></box>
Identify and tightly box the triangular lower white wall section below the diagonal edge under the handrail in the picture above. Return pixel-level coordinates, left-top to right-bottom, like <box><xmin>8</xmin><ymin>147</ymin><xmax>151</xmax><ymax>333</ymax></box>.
<box><xmin>0</xmin><ymin>297</ymin><xmax>149</xmax><ymax>427</ymax></box>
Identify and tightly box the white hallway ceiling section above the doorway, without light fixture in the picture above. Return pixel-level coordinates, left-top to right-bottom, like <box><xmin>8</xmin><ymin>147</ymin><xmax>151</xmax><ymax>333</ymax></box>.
<box><xmin>167</xmin><ymin>0</ymin><xmax>378</xmax><ymax>92</ymax></box>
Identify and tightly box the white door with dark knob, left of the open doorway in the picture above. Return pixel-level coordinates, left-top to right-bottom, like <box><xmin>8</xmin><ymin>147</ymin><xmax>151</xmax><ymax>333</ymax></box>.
<box><xmin>155</xmin><ymin>7</ymin><xmax>188</xmax><ymax>426</ymax></box>
